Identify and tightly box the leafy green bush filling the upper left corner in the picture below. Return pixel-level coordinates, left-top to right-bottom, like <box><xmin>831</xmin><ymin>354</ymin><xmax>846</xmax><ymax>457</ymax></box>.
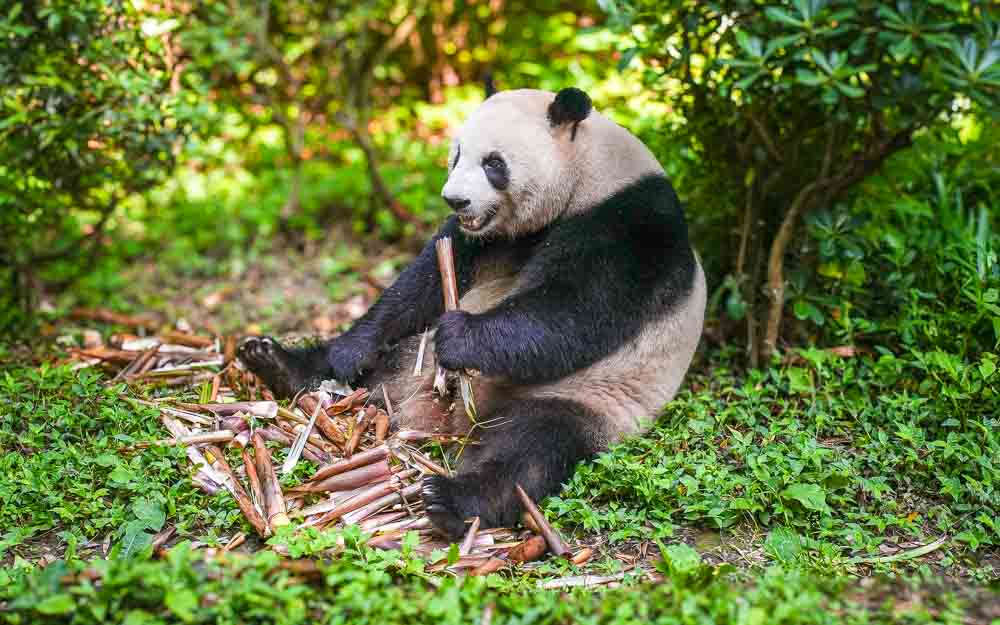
<box><xmin>0</xmin><ymin>1</ymin><xmax>203</xmax><ymax>327</ymax></box>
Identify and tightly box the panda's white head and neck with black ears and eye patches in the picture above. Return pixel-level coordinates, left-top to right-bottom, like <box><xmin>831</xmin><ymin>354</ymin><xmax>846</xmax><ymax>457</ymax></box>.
<box><xmin>441</xmin><ymin>88</ymin><xmax>662</xmax><ymax>238</ymax></box>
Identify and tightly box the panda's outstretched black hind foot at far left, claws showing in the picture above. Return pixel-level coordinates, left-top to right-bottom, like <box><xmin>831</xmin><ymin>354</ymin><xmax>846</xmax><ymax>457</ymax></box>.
<box><xmin>238</xmin><ymin>336</ymin><xmax>329</xmax><ymax>397</ymax></box>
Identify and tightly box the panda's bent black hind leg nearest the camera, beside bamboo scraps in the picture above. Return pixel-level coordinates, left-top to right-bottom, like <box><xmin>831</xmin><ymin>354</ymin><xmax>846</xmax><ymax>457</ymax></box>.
<box><xmin>423</xmin><ymin>399</ymin><xmax>606</xmax><ymax>539</ymax></box>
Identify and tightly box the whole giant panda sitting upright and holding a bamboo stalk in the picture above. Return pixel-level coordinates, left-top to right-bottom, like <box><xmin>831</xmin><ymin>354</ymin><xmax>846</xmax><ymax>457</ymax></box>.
<box><xmin>240</xmin><ymin>88</ymin><xmax>706</xmax><ymax>538</ymax></box>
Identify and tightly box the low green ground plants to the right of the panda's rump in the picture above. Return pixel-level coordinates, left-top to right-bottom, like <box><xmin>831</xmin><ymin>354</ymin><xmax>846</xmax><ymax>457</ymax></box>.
<box><xmin>549</xmin><ymin>350</ymin><xmax>1000</xmax><ymax>569</ymax></box>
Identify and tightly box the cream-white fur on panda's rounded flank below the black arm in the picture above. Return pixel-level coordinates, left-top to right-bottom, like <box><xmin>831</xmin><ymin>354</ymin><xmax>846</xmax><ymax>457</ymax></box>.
<box><xmin>531</xmin><ymin>263</ymin><xmax>706</xmax><ymax>442</ymax></box>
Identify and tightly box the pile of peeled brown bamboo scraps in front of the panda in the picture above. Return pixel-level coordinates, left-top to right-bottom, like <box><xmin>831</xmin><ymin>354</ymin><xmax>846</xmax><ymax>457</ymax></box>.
<box><xmin>140</xmin><ymin>389</ymin><xmax>590</xmax><ymax>575</ymax></box>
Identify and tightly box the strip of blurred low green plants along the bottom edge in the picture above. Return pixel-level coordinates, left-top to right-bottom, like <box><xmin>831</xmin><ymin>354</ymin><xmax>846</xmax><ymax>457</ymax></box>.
<box><xmin>0</xmin><ymin>531</ymin><xmax>984</xmax><ymax>625</ymax></box>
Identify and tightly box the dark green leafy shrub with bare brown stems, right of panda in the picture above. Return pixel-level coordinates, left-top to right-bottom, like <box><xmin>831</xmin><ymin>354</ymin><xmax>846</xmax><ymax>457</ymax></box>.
<box><xmin>606</xmin><ymin>0</ymin><xmax>1000</xmax><ymax>365</ymax></box>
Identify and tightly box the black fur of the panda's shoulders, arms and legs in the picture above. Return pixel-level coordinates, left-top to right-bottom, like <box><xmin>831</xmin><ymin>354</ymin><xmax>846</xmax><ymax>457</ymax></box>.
<box><xmin>240</xmin><ymin>86</ymin><xmax>700</xmax><ymax>538</ymax></box>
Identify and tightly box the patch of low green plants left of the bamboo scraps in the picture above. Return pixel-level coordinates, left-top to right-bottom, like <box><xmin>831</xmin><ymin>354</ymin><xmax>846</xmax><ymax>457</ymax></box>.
<box><xmin>0</xmin><ymin>367</ymin><xmax>225</xmax><ymax>561</ymax></box>
